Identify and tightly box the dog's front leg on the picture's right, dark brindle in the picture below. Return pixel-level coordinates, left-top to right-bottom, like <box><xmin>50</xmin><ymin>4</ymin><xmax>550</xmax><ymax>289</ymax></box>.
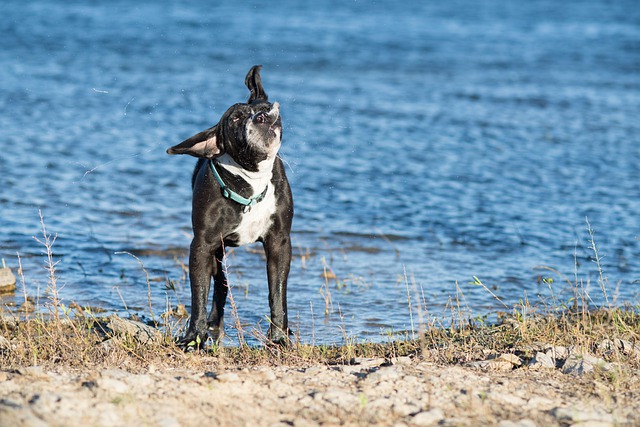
<box><xmin>264</xmin><ymin>235</ymin><xmax>291</xmax><ymax>344</ymax></box>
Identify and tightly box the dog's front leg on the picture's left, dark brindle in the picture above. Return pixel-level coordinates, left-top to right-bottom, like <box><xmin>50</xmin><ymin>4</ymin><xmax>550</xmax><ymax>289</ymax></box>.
<box><xmin>178</xmin><ymin>235</ymin><xmax>217</xmax><ymax>347</ymax></box>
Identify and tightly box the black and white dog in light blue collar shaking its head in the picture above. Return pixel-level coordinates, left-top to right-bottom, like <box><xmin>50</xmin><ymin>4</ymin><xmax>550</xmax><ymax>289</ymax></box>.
<box><xmin>167</xmin><ymin>65</ymin><xmax>293</xmax><ymax>348</ymax></box>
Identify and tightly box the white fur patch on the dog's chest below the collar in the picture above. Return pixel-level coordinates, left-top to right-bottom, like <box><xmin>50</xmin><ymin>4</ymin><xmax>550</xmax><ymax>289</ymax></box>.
<box><xmin>233</xmin><ymin>184</ymin><xmax>276</xmax><ymax>246</ymax></box>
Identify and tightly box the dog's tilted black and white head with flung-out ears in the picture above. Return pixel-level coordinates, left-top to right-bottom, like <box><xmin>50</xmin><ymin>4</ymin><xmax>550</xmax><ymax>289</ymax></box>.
<box><xmin>167</xmin><ymin>65</ymin><xmax>282</xmax><ymax>171</ymax></box>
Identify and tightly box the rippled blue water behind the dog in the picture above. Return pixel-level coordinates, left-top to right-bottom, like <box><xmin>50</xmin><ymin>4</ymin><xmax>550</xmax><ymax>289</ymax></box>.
<box><xmin>0</xmin><ymin>0</ymin><xmax>640</xmax><ymax>343</ymax></box>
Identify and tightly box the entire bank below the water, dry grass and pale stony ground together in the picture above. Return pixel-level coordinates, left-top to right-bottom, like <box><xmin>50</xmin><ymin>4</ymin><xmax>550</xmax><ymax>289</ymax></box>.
<box><xmin>0</xmin><ymin>310</ymin><xmax>640</xmax><ymax>427</ymax></box>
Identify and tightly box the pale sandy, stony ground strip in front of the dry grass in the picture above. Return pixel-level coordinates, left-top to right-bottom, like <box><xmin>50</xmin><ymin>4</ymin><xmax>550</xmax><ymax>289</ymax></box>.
<box><xmin>0</xmin><ymin>357</ymin><xmax>640</xmax><ymax>427</ymax></box>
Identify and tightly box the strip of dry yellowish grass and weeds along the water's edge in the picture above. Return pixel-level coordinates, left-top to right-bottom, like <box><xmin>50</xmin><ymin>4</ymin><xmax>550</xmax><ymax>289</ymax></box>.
<box><xmin>0</xmin><ymin>217</ymin><xmax>640</xmax><ymax>382</ymax></box>
